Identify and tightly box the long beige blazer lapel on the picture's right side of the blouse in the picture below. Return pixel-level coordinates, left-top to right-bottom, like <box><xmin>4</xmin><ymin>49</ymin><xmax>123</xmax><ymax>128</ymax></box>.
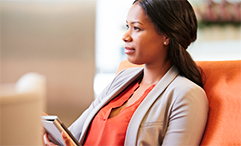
<box><xmin>125</xmin><ymin>66</ymin><xmax>178</xmax><ymax>146</ymax></box>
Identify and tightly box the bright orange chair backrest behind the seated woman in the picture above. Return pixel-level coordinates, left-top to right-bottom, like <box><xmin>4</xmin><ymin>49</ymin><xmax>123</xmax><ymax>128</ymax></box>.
<box><xmin>117</xmin><ymin>60</ymin><xmax>241</xmax><ymax>146</ymax></box>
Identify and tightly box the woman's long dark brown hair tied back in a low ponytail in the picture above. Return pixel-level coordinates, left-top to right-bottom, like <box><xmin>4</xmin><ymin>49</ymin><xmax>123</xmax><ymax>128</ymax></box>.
<box><xmin>133</xmin><ymin>0</ymin><xmax>203</xmax><ymax>87</ymax></box>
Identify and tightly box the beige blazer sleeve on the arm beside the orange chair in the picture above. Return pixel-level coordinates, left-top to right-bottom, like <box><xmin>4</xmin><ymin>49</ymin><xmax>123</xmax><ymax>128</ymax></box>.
<box><xmin>162</xmin><ymin>86</ymin><xmax>208</xmax><ymax>146</ymax></box>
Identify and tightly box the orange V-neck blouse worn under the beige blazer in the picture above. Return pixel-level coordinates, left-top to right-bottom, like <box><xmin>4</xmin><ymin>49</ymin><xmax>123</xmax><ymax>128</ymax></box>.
<box><xmin>84</xmin><ymin>81</ymin><xmax>155</xmax><ymax>146</ymax></box>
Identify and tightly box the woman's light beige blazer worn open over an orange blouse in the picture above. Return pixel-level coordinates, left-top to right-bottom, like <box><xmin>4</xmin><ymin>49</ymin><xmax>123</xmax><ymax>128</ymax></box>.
<box><xmin>69</xmin><ymin>66</ymin><xmax>208</xmax><ymax>146</ymax></box>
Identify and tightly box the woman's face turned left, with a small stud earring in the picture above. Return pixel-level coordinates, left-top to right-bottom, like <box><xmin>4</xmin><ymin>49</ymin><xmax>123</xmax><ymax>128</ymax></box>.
<box><xmin>122</xmin><ymin>3</ymin><xmax>169</xmax><ymax>64</ymax></box>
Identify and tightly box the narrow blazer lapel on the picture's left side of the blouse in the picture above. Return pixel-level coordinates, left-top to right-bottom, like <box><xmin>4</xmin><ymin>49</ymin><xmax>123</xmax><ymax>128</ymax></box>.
<box><xmin>79</xmin><ymin>68</ymin><xmax>143</xmax><ymax>144</ymax></box>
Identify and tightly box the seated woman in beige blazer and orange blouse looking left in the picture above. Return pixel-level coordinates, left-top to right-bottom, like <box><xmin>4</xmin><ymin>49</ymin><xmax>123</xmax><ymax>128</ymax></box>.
<box><xmin>45</xmin><ymin>0</ymin><xmax>208</xmax><ymax>146</ymax></box>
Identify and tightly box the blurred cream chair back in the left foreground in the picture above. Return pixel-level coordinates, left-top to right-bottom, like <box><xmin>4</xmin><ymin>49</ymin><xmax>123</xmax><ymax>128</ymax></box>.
<box><xmin>0</xmin><ymin>73</ymin><xmax>46</xmax><ymax>145</ymax></box>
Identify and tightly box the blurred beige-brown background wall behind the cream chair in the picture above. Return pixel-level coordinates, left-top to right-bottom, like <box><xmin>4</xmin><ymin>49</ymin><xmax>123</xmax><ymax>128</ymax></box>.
<box><xmin>0</xmin><ymin>0</ymin><xmax>96</xmax><ymax>125</ymax></box>
